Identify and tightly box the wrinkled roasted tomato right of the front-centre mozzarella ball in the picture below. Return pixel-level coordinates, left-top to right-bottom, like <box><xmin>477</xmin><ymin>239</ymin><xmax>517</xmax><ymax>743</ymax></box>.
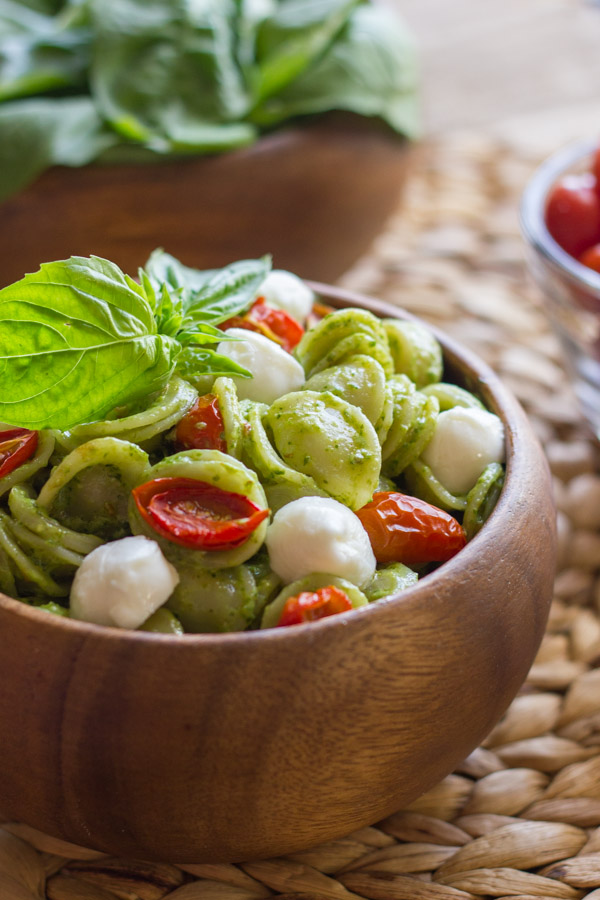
<box><xmin>356</xmin><ymin>491</ymin><xmax>467</xmax><ymax>566</ymax></box>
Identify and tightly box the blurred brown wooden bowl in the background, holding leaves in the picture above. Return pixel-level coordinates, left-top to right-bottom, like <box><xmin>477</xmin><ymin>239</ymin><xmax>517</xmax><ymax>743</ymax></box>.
<box><xmin>0</xmin><ymin>114</ymin><xmax>409</xmax><ymax>287</ymax></box>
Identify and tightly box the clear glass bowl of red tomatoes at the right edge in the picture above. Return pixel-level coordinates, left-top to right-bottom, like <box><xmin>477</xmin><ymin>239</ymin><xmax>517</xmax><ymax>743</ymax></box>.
<box><xmin>521</xmin><ymin>141</ymin><xmax>600</xmax><ymax>436</ymax></box>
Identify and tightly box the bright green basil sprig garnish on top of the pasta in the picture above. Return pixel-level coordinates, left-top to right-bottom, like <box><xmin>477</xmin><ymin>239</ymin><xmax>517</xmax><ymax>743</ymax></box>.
<box><xmin>0</xmin><ymin>253</ymin><xmax>270</xmax><ymax>430</ymax></box>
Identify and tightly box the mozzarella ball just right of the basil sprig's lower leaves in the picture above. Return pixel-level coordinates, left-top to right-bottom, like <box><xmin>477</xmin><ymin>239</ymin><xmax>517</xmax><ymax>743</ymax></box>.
<box><xmin>217</xmin><ymin>328</ymin><xmax>306</xmax><ymax>404</ymax></box>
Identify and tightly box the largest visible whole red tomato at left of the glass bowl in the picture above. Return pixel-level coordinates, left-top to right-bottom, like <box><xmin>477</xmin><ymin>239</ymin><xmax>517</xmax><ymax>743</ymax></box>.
<box><xmin>546</xmin><ymin>172</ymin><xmax>600</xmax><ymax>257</ymax></box>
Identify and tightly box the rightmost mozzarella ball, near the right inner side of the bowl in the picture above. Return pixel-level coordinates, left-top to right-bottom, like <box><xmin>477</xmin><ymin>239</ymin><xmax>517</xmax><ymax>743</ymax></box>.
<box><xmin>421</xmin><ymin>406</ymin><xmax>504</xmax><ymax>494</ymax></box>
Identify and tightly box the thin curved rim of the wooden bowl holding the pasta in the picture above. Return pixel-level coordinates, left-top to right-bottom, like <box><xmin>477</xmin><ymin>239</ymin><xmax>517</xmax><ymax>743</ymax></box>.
<box><xmin>0</xmin><ymin>281</ymin><xmax>541</xmax><ymax>649</ymax></box>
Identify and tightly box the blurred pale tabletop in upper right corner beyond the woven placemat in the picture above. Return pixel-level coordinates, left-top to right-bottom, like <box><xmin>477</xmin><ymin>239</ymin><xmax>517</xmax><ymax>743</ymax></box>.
<box><xmin>392</xmin><ymin>0</ymin><xmax>600</xmax><ymax>134</ymax></box>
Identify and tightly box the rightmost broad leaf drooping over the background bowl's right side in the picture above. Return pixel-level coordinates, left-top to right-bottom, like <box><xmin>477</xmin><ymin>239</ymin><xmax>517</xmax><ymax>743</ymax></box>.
<box><xmin>253</xmin><ymin>5</ymin><xmax>419</xmax><ymax>137</ymax></box>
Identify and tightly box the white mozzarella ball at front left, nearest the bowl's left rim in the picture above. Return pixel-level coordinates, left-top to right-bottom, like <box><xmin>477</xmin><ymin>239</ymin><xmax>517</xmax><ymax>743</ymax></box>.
<box><xmin>71</xmin><ymin>535</ymin><xmax>179</xmax><ymax>628</ymax></box>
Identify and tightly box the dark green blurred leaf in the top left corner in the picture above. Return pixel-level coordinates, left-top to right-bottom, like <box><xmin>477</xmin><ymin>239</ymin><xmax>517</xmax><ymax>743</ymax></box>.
<box><xmin>0</xmin><ymin>0</ymin><xmax>91</xmax><ymax>101</ymax></box>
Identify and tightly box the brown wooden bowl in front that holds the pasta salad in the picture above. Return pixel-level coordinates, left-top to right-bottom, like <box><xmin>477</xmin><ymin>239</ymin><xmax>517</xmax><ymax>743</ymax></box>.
<box><xmin>0</xmin><ymin>286</ymin><xmax>555</xmax><ymax>862</ymax></box>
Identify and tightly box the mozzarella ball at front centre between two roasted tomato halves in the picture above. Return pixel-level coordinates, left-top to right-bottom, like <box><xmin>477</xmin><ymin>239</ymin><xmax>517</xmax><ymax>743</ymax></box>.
<box><xmin>266</xmin><ymin>497</ymin><xmax>376</xmax><ymax>587</ymax></box>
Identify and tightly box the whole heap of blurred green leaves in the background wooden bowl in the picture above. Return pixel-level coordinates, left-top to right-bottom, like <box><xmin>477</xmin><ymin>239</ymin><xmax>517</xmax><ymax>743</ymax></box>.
<box><xmin>0</xmin><ymin>0</ymin><xmax>416</xmax><ymax>202</ymax></box>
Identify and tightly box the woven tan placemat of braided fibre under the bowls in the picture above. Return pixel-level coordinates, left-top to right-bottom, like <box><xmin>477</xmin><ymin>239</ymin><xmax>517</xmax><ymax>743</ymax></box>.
<box><xmin>0</xmin><ymin>128</ymin><xmax>600</xmax><ymax>900</ymax></box>
